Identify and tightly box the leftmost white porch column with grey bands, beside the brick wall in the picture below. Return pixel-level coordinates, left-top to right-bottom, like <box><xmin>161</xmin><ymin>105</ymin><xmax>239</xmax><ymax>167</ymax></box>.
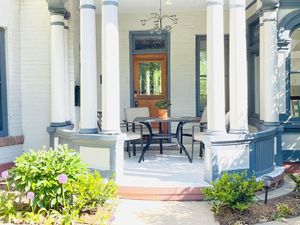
<box><xmin>51</xmin><ymin>12</ymin><xmax>66</xmax><ymax>127</ymax></box>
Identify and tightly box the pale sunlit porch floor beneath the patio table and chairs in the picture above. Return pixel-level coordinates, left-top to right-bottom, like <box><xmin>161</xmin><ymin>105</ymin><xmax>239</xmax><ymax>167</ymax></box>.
<box><xmin>119</xmin><ymin>144</ymin><xmax>209</xmax><ymax>188</ymax></box>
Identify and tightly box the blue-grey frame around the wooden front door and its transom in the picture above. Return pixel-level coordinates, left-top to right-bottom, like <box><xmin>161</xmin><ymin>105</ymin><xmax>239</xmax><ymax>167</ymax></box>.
<box><xmin>129</xmin><ymin>31</ymin><xmax>171</xmax><ymax>112</ymax></box>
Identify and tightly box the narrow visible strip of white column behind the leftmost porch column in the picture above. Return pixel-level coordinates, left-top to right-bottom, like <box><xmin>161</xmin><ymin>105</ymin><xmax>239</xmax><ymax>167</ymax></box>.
<box><xmin>64</xmin><ymin>15</ymin><xmax>71</xmax><ymax>125</ymax></box>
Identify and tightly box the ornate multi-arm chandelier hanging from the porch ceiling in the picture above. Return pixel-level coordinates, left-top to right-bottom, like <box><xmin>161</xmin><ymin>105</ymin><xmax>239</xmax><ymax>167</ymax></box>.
<box><xmin>141</xmin><ymin>0</ymin><xmax>178</xmax><ymax>34</ymax></box>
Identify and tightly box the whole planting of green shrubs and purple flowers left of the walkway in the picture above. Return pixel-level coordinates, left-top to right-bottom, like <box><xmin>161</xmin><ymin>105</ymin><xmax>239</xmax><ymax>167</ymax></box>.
<box><xmin>0</xmin><ymin>146</ymin><xmax>117</xmax><ymax>225</ymax></box>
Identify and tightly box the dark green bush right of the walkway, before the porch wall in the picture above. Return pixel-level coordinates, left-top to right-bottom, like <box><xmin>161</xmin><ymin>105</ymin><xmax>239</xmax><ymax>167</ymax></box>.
<box><xmin>204</xmin><ymin>172</ymin><xmax>263</xmax><ymax>213</ymax></box>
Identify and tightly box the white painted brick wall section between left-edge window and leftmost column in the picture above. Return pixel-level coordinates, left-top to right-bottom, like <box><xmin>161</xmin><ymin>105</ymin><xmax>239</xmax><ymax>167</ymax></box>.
<box><xmin>20</xmin><ymin>0</ymin><xmax>50</xmax><ymax>151</ymax></box>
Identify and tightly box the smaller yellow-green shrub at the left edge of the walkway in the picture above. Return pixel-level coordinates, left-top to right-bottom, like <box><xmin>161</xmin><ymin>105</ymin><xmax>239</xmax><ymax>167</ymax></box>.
<box><xmin>67</xmin><ymin>171</ymin><xmax>117</xmax><ymax>211</ymax></box>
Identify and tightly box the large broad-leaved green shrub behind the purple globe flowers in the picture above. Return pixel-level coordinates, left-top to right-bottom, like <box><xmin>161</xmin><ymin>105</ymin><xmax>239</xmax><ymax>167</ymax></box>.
<box><xmin>11</xmin><ymin>146</ymin><xmax>87</xmax><ymax>209</ymax></box>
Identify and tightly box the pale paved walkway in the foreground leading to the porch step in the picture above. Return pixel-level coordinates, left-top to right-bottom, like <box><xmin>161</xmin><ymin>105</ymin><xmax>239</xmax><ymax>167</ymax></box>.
<box><xmin>112</xmin><ymin>200</ymin><xmax>219</xmax><ymax>225</ymax></box>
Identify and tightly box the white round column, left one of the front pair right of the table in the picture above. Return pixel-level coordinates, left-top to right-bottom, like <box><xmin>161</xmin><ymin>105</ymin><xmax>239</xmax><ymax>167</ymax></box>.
<box><xmin>207</xmin><ymin>0</ymin><xmax>226</xmax><ymax>134</ymax></box>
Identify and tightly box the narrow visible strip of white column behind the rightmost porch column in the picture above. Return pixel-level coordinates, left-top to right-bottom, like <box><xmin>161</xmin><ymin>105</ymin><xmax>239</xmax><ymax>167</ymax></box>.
<box><xmin>259</xmin><ymin>14</ymin><xmax>265</xmax><ymax>121</ymax></box>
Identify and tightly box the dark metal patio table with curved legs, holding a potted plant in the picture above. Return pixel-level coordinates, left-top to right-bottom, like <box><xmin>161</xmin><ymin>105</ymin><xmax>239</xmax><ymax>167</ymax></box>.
<box><xmin>133</xmin><ymin>116</ymin><xmax>201</xmax><ymax>163</ymax></box>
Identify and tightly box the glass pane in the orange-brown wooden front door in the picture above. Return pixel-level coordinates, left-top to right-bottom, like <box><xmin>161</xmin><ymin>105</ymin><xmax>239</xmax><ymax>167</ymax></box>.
<box><xmin>139</xmin><ymin>62</ymin><xmax>162</xmax><ymax>95</ymax></box>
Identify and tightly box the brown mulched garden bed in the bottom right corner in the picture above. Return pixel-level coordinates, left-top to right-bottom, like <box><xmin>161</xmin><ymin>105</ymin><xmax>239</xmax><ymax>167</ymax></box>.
<box><xmin>216</xmin><ymin>191</ymin><xmax>300</xmax><ymax>225</ymax></box>
